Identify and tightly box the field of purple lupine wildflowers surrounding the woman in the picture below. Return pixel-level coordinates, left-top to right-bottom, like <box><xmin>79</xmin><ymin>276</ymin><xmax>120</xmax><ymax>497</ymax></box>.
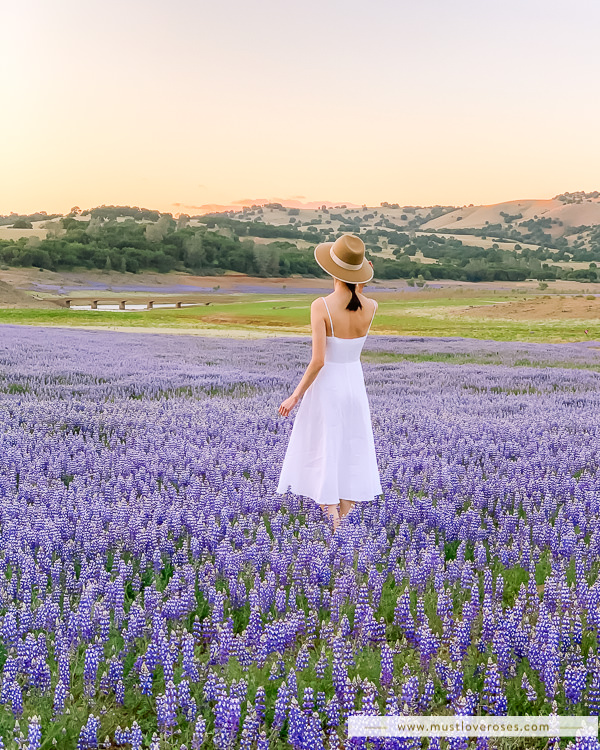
<box><xmin>0</xmin><ymin>325</ymin><xmax>600</xmax><ymax>750</ymax></box>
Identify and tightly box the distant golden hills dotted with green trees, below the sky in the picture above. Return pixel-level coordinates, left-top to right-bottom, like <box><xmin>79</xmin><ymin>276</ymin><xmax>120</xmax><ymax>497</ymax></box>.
<box><xmin>0</xmin><ymin>192</ymin><xmax>600</xmax><ymax>283</ymax></box>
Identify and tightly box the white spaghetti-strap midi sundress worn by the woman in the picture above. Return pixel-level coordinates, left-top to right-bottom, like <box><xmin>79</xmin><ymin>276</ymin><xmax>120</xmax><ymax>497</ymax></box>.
<box><xmin>277</xmin><ymin>297</ymin><xmax>383</xmax><ymax>505</ymax></box>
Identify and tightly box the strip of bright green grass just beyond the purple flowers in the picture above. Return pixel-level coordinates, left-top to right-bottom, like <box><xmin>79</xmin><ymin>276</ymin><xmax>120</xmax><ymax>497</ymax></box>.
<box><xmin>0</xmin><ymin>292</ymin><xmax>600</xmax><ymax>343</ymax></box>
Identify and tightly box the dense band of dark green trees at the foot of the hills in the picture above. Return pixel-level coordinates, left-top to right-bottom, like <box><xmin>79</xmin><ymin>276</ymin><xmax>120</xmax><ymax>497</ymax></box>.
<box><xmin>0</xmin><ymin>214</ymin><xmax>600</xmax><ymax>281</ymax></box>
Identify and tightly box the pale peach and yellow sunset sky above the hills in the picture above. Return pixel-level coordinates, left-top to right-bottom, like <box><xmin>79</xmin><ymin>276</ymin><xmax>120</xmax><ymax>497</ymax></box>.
<box><xmin>0</xmin><ymin>0</ymin><xmax>600</xmax><ymax>215</ymax></box>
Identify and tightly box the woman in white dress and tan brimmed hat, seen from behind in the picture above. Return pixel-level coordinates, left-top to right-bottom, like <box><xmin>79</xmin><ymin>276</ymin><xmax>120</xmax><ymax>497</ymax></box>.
<box><xmin>277</xmin><ymin>234</ymin><xmax>382</xmax><ymax>532</ymax></box>
